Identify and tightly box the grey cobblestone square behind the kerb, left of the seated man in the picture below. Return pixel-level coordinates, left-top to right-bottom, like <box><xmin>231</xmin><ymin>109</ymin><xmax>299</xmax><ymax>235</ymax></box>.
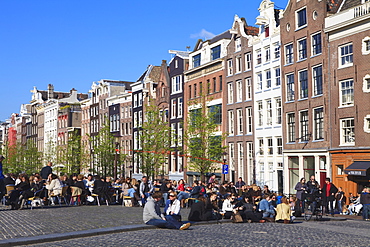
<box><xmin>0</xmin><ymin>205</ymin><xmax>189</xmax><ymax>240</ymax></box>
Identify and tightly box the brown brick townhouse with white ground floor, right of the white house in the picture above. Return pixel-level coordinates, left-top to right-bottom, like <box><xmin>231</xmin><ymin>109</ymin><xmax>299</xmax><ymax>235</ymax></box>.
<box><xmin>280</xmin><ymin>0</ymin><xmax>338</xmax><ymax>193</ymax></box>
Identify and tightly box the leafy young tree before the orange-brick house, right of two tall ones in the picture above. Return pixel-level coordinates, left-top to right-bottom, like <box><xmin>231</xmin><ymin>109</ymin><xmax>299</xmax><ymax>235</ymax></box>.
<box><xmin>183</xmin><ymin>96</ymin><xmax>226</xmax><ymax>181</ymax></box>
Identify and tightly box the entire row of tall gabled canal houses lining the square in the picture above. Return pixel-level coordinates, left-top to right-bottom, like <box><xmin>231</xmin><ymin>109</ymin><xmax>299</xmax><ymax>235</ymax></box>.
<box><xmin>1</xmin><ymin>0</ymin><xmax>370</xmax><ymax>196</ymax></box>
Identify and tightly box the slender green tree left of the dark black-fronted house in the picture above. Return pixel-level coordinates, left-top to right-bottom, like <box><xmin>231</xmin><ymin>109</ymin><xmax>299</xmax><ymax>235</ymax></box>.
<box><xmin>136</xmin><ymin>101</ymin><xmax>171</xmax><ymax>178</ymax></box>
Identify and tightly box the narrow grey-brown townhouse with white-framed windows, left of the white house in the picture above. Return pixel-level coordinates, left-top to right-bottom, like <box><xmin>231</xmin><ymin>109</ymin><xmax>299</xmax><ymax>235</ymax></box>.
<box><xmin>223</xmin><ymin>16</ymin><xmax>258</xmax><ymax>184</ymax></box>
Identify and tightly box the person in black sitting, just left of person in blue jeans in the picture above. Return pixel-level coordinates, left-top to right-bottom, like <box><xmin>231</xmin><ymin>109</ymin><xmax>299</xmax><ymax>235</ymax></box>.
<box><xmin>234</xmin><ymin>197</ymin><xmax>265</xmax><ymax>223</ymax></box>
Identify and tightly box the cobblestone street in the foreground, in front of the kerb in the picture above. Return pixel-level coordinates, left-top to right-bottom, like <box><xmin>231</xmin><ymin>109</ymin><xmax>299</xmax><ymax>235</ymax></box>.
<box><xmin>26</xmin><ymin>220</ymin><xmax>370</xmax><ymax>247</ymax></box>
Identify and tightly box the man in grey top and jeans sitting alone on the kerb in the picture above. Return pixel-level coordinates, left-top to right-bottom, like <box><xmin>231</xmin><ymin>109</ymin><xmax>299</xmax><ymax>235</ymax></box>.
<box><xmin>143</xmin><ymin>192</ymin><xmax>190</xmax><ymax>230</ymax></box>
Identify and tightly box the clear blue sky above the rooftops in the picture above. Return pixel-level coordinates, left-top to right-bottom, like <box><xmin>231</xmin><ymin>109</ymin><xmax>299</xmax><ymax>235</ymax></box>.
<box><xmin>0</xmin><ymin>0</ymin><xmax>288</xmax><ymax>120</ymax></box>
